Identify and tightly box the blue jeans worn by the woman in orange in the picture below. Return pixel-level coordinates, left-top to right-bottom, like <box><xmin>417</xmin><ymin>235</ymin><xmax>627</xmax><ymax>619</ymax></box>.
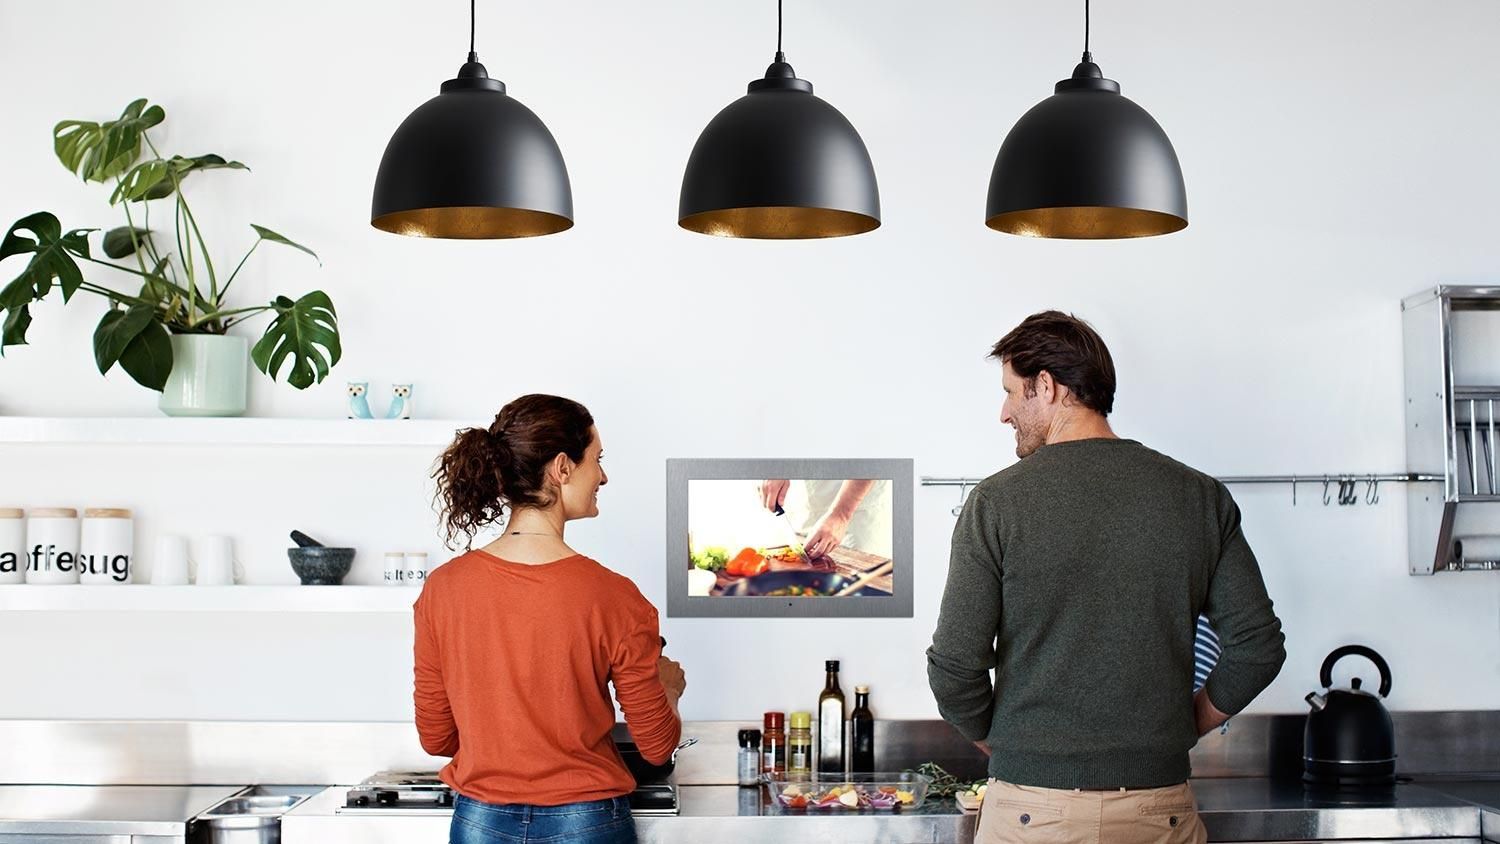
<box><xmin>449</xmin><ymin>795</ymin><xmax>636</xmax><ymax>844</ymax></box>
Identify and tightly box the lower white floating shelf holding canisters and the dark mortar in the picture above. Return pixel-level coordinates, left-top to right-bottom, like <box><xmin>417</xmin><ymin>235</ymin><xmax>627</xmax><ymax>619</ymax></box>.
<box><xmin>0</xmin><ymin>583</ymin><xmax>422</xmax><ymax>613</ymax></box>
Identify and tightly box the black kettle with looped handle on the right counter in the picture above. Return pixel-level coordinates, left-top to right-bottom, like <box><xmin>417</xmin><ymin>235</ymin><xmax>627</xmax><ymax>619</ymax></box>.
<box><xmin>1302</xmin><ymin>645</ymin><xmax>1397</xmax><ymax>789</ymax></box>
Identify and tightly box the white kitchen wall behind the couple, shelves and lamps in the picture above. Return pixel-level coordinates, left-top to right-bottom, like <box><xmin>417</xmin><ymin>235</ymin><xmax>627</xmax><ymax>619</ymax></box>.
<box><xmin>0</xmin><ymin>0</ymin><xmax>1500</xmax><ymax>720</ymax></box>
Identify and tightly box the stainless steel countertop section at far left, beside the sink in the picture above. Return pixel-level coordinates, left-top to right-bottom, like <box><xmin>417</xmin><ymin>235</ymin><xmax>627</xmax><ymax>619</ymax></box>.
<box><xmin>0</xmin><ymin>786</ymin><xmax>245</xmax><ymax>837</ymax></box>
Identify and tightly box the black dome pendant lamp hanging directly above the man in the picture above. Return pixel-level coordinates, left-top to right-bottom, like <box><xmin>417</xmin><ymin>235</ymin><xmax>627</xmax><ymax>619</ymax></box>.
<box><xmin>984</xmin><ymin>0</ymin><xmax>1188</xmax><ymax>238</ymax></box>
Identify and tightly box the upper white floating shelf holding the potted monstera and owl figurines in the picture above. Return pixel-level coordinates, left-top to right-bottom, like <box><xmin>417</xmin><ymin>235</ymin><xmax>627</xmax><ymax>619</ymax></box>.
<box><xmin>0</xmin><ymin>417</ymin><xmax>474</xmax><ymax>448</ymax></box>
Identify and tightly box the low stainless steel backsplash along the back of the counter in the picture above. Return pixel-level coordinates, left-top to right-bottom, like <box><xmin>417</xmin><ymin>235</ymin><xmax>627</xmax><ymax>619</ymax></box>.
<box><xmin>0</xmin><ymin>711</ymin><xmax>1500</xmax><ymax>786</ymax></box>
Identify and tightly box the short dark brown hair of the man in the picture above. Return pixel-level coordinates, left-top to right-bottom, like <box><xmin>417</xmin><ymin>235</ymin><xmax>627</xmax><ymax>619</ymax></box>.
<box><xmin>990</xmin><ymin>310</ymin><xmax>1115</xmax><ymax>417</ymax></box>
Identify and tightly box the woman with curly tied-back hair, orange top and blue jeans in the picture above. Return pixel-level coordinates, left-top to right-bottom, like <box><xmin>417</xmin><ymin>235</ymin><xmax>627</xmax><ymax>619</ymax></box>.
<box><xmin>414</xmin><ymin>396</ymin><xmax>686</xmax><ymax>844</ymax></box>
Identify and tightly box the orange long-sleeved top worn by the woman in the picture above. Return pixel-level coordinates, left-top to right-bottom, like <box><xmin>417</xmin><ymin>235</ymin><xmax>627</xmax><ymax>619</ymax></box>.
<box><xmin>413</xmin><ymin>550</ymin><xmax>683</xmax><ymax>805</ymax></box>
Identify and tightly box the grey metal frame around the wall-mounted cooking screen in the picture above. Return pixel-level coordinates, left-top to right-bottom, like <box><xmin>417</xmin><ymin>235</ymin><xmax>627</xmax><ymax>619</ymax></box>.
<box><xmin>666</xmin><ymin>457</ymin><xmax>915</xmax><ymax>618</ymax></box>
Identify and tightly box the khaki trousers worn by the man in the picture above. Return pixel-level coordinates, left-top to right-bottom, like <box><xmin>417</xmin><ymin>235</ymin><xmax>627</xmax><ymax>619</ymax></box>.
<box><xmin>974</xmin><ymin>780</ymin><xmax>1208</xmax><ymax>844</ymax></box>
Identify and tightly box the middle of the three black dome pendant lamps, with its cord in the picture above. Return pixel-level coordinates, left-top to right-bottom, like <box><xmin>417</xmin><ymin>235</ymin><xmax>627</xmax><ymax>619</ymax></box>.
<box><xmin>677</xmin><ymin>0</ymin><xmax>881</xmax><ymax>240</ymax></box>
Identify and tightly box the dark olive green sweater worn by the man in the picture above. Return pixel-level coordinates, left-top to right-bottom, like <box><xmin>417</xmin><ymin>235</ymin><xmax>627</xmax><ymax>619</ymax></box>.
<box><xmin>927</xmin><ymin>439</ymin><xmax>1286</xmax><ymax>789</ymax></box>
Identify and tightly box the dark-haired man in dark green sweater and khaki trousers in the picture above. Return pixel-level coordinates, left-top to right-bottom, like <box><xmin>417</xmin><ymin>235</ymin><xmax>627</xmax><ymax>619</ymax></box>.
<box><xmin>927</xmin><ymin>310</ymin><xmax>1286</xmax><ymax>844</ymax></box>
